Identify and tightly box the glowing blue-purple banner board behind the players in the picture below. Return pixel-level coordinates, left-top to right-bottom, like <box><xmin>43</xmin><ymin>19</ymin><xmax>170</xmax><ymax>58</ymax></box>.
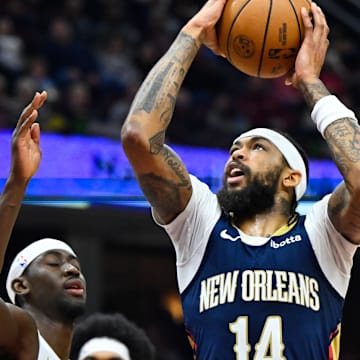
<box><xmin>0</xmin><ymin>131</ymin><xmax>341</xmax><ymax>202</ymax></box>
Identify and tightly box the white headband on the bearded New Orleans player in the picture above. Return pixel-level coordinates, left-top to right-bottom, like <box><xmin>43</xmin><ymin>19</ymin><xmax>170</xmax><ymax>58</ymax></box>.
<box><xmin>234</xmin><ymin>128</ymin><xmax>307</xmax><ymax>200</ymax></box>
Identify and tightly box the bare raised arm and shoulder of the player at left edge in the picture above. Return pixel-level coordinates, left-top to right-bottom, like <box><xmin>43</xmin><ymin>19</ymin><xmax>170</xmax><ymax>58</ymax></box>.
<box><xmin>0</xmin><ymin>92</ymin><xmax>47</xmax><ymax>357</ymax></box>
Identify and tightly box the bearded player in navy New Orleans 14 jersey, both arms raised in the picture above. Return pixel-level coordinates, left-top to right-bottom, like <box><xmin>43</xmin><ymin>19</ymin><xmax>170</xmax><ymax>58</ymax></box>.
<box><xmin>121</xmin><ymin>0</ymin><xmax>360</xmax><ymax>360</ymax></box>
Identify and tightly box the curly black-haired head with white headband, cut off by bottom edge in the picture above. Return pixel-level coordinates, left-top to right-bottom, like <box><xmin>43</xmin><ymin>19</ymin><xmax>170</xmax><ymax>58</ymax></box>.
<box><xmin>71</xmin><ymin>313</ymin><xmax>155</xmax><ymax>360</ymax></box>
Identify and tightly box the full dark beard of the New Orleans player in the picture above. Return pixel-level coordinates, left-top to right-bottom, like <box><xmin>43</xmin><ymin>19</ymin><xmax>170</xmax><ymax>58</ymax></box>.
<box><xmin>217</xmin><ymin>166</ymin><xmax>282</xmax><ymax>221</ymax></box>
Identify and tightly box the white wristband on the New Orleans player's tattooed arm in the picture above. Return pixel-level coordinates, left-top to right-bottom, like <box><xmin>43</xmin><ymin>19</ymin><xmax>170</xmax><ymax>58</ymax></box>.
<box><xmin>311</xmin><ymin>95</ymin><xmax>356</xmax><ymax>137</ymax></box>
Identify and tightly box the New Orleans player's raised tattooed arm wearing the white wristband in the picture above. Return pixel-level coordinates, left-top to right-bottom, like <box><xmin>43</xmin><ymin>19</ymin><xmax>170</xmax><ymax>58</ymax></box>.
<box><xmin>290</xmin><ymin>3</ymin><xmax>360</xmax><ymax>244</ymax></box>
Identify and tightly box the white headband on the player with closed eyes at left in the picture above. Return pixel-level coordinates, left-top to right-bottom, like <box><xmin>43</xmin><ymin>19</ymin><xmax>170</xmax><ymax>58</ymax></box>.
<box><xmin>6</xmin><ymin>238</ymin><xmax>76</xmax><ymax>304</ymax></box>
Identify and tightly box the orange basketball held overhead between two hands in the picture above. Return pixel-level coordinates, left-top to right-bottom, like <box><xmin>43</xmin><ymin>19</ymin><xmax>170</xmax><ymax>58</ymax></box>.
<box><xmin>216</xmin><ymin>0</ymin><xmax>311</xmax><ymax>78</ymax></box>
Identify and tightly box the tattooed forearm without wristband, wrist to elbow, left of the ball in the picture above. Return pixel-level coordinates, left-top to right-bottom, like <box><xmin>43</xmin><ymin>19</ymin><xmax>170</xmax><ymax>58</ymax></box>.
<box><xmin>131</xmin><ymin>33</ymin><xmax>198</xmax><ymax>119</ymax></box>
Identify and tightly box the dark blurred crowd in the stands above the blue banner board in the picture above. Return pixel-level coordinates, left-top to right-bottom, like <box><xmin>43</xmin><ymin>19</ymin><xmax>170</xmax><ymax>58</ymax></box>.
<box><xmin>0</xmin><ymin>0</ymin><xmax>360</xmax><ymax>157</ymax></box>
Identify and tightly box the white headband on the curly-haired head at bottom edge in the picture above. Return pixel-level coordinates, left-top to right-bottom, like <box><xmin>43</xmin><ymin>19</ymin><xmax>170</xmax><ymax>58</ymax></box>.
<box><xmin>78</xmin><ymin>337</ymin><xmax>131</xmax><ymax>360</ymax></box>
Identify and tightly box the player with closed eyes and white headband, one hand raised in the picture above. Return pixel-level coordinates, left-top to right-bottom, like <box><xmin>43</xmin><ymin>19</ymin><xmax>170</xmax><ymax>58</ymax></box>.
<box><xmin>0</xmin><ymin>92</ymin><xmax>86</xmax><ymax>360</ymax></box>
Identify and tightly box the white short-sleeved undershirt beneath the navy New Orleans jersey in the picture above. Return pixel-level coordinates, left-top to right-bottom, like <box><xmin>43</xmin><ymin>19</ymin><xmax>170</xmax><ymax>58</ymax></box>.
<box><xmin>155</xmin><ymin>175</ymin><xmax>357</xmax><ymax>297</ymax></box>
